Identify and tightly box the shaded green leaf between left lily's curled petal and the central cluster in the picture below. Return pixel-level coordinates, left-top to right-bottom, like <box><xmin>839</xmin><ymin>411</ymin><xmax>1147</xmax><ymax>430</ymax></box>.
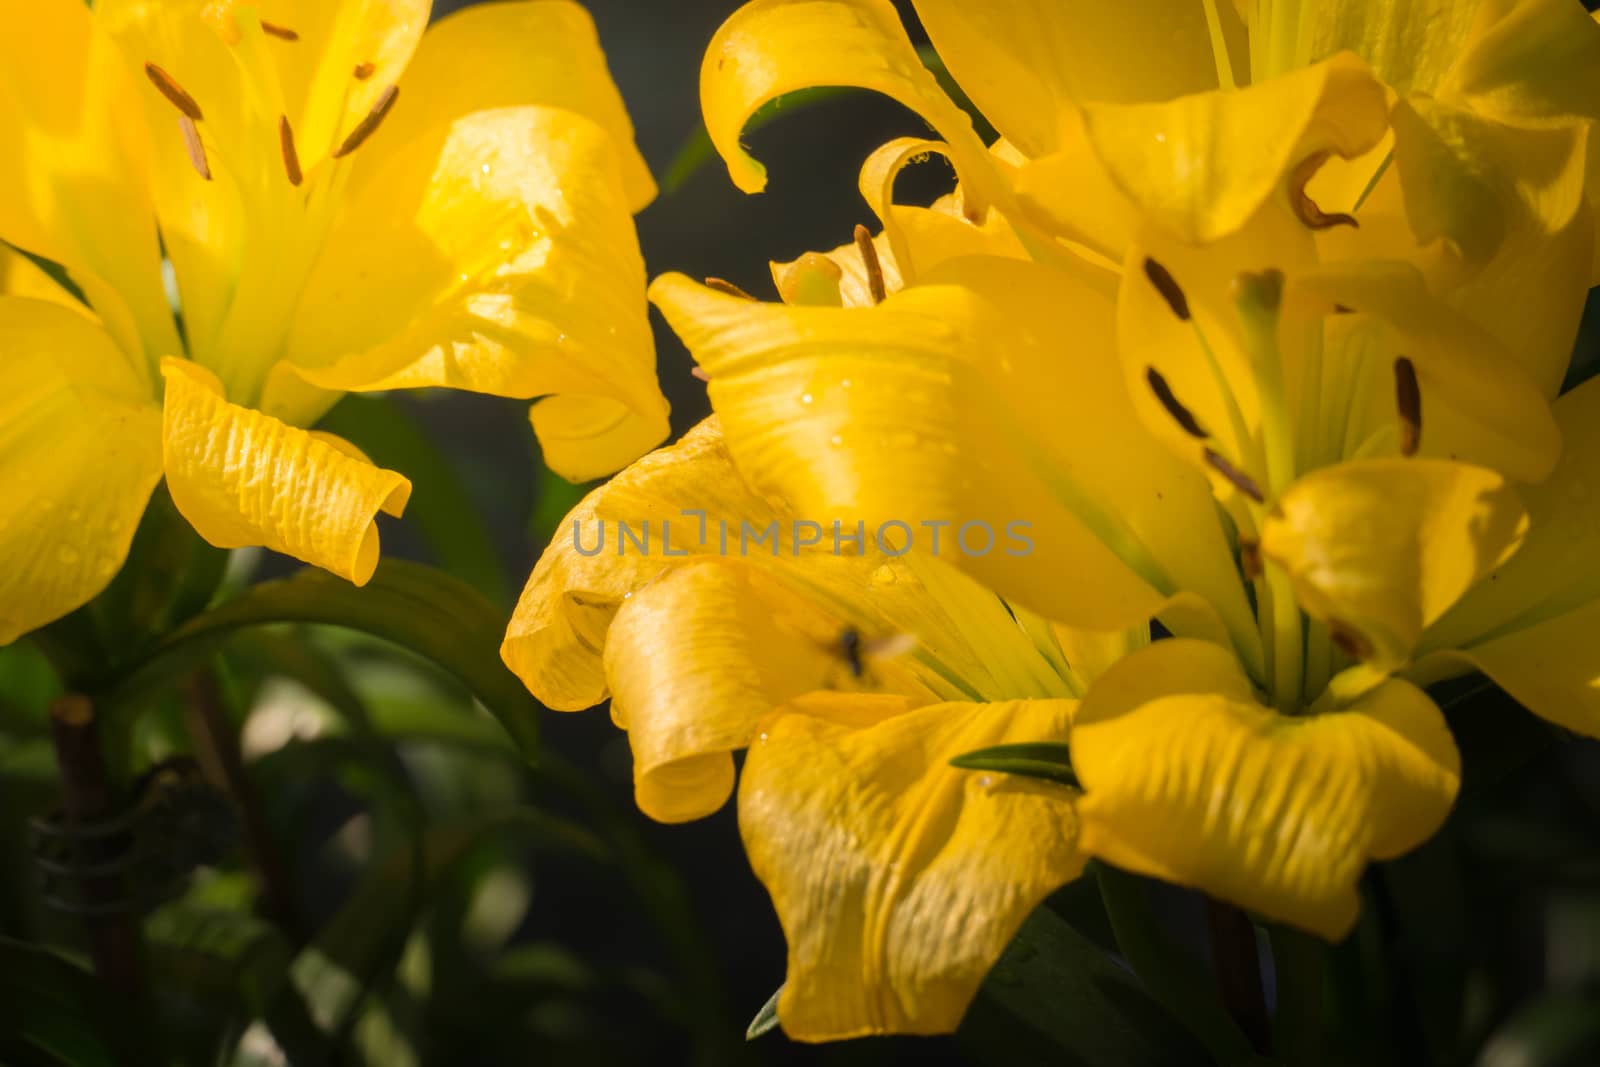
<box><xmin>318</xmin><ymin>395</ymin><xmax>510</xmax><ymax>605</ymax></box>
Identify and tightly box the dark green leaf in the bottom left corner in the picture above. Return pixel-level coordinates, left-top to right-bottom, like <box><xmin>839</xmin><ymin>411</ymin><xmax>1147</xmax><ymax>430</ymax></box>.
<box><xmin>0</xmin><ymin>937</ymin><xmax>155</xmax><ymax>1067</ymax></box>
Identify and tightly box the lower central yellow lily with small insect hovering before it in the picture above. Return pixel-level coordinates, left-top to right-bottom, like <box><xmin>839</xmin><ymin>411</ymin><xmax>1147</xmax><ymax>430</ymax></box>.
<box><xmin>501</xmin><ymin>418</ymin><xmax>1094</xmax><ymax>1040</ymax></box>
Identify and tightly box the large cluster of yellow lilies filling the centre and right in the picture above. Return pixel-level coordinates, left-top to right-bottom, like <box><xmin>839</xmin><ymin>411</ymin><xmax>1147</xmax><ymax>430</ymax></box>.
<box><xmin>502</xmin><ymin>0</ymin><xmax>1600</xmax><ymax>1040</ymax></box>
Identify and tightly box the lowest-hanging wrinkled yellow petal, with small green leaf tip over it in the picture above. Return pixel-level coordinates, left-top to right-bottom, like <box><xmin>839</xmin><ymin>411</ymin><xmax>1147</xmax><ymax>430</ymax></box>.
<box><xmin>739</xmin><ymin>696</ymin><xmax>1083</xmax><ymax>1041</ymax></box>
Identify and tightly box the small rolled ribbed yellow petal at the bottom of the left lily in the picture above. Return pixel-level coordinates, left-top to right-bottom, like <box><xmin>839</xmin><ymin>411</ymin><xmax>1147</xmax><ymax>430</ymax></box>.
<box><xmin>162</xmin><ymin>357</ymin><xmax>411</xmax><ymax>585</ymax></box>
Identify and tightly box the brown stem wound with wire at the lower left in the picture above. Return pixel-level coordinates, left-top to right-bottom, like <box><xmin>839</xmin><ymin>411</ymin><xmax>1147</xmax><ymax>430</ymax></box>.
<box><xmin>50</xmin><ymin>693</ymin><xmax>144</xmax><ymax>995</ymax></box>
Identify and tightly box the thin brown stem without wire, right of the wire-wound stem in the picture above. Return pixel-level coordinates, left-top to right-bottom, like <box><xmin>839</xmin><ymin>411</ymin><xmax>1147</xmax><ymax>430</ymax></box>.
<box><xmin>186</xmin><ymin>670</ymin><xmax>299</xmax><ymax>936</ymax></box>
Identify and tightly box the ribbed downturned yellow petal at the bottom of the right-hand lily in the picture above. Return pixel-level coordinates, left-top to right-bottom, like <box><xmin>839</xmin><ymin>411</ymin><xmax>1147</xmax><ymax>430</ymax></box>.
<box><xmin>1072</xmin><ymin>638</ymin><xmax>1461</xmax><ymax>941</ymax></box>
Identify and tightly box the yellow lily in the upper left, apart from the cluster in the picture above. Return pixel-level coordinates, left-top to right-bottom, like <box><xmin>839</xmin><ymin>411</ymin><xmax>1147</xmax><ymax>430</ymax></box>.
<box><xmin>0</xmin><ymin>0</ymin><xmax>667</xmax><ymax>643</ymax></box>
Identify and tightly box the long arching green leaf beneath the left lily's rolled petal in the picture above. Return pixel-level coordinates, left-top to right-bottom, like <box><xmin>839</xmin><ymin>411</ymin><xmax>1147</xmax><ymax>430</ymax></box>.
<box><xmin>114</xmin><ymin>560</ymin><xmax>539</xmax><ymax>760</ymax></box>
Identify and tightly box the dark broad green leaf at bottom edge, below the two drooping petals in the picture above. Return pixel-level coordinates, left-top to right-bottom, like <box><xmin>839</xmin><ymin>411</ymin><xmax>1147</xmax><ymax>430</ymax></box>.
<box><xmin>960</xmin><ymin>907</ymin><xmax>1205</xmax><ymax>1067</ymax></box>
